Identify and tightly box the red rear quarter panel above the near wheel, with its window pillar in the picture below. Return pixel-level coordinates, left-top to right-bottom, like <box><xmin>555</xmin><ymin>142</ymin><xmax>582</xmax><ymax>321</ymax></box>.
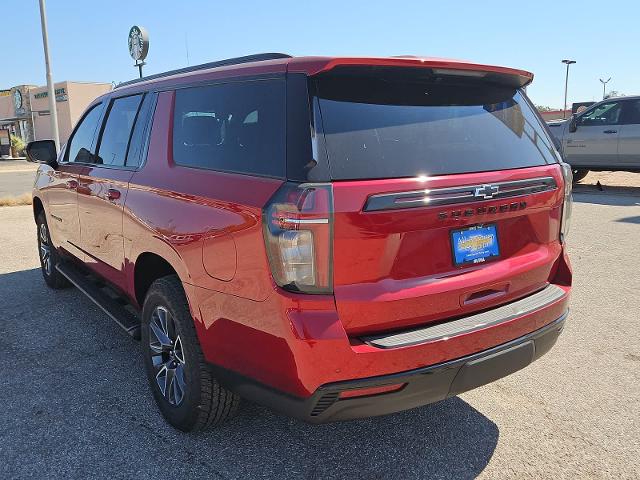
<box><xmin>123</xmin><ymin>92</ymin><xmax>283</xmax><ymax>308</ymax></box>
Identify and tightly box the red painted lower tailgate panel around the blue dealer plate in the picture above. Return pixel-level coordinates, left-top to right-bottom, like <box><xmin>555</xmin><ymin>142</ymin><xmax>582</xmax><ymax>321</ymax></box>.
<box><xmin>334</xmin><ymin>165</ymin><xmax>562</xmax><ymax>335</ymax></box>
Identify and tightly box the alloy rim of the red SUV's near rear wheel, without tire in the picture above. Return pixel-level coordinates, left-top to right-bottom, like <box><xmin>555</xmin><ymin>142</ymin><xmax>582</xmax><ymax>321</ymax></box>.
<box><xmin>149</xmin><ymin>306</ymin><xmax>186</xmax><ymax>406</ymax></box>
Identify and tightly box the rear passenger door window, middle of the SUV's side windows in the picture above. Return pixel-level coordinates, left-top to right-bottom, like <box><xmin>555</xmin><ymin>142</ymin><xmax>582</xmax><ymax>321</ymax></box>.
<box><xmin>94</xmin><ymin>95</ymin><xmax>142</xmax><ymax>167</ymax></box>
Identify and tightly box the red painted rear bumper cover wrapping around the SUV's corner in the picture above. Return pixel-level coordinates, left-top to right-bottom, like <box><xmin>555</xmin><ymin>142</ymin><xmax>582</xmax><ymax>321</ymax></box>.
<box><xmin>188</xmin><ymin>274</ymin><xmax>570</xmax><ymax>397</ymax></box>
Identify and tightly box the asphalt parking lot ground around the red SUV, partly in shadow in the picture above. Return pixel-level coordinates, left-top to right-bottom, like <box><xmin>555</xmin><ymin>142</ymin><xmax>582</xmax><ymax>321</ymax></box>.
<box><xmin>0</xmin><ymin>181</ymin><xmax>640</xmax><ymax>479</ymax></box>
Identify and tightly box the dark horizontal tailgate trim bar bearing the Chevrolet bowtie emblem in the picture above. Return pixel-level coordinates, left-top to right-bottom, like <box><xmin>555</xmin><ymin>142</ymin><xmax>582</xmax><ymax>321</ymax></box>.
<box><xmin>364</xmin><ymin>177</ymin><xmax>558</xmax><ymax>212</ymax></box>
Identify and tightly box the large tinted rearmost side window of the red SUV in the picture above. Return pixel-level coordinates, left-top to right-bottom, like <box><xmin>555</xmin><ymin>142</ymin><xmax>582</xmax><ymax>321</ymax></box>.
<box><xmin>173</xmin><ymin>80</ymin><xmax>286</xmax><ymax>177</ymax></box>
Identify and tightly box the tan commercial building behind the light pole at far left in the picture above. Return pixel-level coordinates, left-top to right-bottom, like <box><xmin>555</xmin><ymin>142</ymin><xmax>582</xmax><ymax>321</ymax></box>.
<box><xmin>0</xmin><ymin>81</ymin><xmax>112</xmax><ymax>156</ymax></box>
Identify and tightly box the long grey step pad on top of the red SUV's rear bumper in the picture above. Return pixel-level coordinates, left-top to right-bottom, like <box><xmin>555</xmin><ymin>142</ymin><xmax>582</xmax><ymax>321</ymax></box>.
<box><xmin>361</xmin><ymin>285</ymin><xmax>565</xmax><ymax>348</ymax></box>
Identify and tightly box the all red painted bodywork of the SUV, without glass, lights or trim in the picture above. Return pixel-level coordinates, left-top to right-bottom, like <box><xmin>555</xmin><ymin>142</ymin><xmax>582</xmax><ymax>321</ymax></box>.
<box><xmin>34</xmin><ymin>57</ymin><xmax>571</xmax><ymax>404</ymax></box>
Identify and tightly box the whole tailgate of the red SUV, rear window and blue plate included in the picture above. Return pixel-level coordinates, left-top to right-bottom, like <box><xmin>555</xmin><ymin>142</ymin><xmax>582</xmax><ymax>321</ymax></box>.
<box><xmin>311</xmin><ymin>66</ymin><xmax>564</xmax><ymax>335</ymax></box>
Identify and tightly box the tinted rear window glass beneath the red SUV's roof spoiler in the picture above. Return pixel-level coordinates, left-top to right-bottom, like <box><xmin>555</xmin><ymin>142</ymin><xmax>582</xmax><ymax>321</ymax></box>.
<box><xmin>315</xmin><ymin>75</ymin><xmax>557</xmax><ymax>180</ymax></box>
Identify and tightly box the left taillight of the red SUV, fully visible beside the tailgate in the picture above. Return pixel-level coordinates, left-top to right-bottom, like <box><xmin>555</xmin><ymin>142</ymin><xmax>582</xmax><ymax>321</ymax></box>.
<box><xmin>263</xmin><ymin>183</ymin><xmax>333</xmax><ymax>293</ymax></box>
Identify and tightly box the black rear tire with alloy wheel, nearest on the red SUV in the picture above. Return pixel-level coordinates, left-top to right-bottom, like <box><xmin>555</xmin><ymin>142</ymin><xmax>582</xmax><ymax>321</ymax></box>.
<box><xmin>141</xmin><ymin>275</ymin><xmax>240</xmax><ymax>432</ymax></box>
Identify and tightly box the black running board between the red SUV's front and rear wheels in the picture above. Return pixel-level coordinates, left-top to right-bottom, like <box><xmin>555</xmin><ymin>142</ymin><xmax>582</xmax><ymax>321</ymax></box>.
<box><xmin>56</xmin><ymin>262</ymin><xmax>140</xmax><ymax>340</ymax></box>
